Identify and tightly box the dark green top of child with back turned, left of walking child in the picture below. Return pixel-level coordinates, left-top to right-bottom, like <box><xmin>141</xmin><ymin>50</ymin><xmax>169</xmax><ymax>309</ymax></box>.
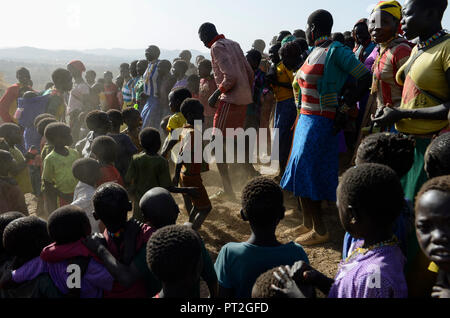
<box><xmin>125</xmin><ymin>152</ymin><xmax>172</xmax><ymax>200</ymax></box>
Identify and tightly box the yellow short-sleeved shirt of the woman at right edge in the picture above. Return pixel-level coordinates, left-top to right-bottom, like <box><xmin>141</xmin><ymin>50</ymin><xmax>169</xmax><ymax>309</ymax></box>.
<box><xmin>396</xmin><ymin>38</ymin><xmax>450</xmax><ymax>134</ymax></box>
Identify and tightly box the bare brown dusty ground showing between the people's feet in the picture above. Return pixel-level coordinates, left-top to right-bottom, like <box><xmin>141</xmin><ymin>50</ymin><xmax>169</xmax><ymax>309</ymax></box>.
<box><xmin>26</xmin><ymin>161</ymin><xmax>344</xmax><ymax>296</ymax></box>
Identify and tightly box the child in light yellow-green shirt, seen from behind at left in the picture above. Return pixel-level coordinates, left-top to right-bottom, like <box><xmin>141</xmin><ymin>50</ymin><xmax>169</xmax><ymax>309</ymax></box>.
<box><xmin>42</xmin><ymin>123</ymin><xmax>80</xmax><ymax>215</ymax></box>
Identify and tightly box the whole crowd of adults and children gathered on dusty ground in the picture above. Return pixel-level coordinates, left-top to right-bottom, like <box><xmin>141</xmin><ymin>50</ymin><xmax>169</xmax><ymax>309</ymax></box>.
<box><xmin>0</xmin><ymin>0</ymin><xmax>450</xmax><ymax>298</ymax></box>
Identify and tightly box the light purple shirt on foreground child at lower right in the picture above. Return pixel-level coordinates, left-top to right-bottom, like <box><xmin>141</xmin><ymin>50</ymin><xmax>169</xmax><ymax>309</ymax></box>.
<box><xmin>328</xmin><ymin>242</ymin><xmax>408</xmax><ymax>298</ymax></box>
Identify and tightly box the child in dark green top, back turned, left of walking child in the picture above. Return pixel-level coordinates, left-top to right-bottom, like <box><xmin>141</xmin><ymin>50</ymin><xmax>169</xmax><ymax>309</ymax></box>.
<box><xmin>125</xmin><ymin>128</ymin><xmax>193</xmax><ymax>222</ymax></box>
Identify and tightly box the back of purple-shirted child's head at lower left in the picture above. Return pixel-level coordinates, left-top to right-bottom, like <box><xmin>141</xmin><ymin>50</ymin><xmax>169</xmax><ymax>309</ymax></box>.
<box><xmin>47</xmin><ymin>205</ymin><xmax>91</xmax><ymax>245</ymax></box>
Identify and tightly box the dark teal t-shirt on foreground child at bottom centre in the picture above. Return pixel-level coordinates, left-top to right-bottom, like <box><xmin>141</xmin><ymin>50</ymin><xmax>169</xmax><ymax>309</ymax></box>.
<box><xmin>214</xmin><ymin>242</ymin><xmax>309</xmax><ymax>298</ymax></box>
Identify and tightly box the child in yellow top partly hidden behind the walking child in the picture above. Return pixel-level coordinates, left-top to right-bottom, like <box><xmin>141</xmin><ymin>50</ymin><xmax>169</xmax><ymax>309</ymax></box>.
<box><xmin>162</xmin><ymin>88</ymin><xmax>192</xmax><ymax>159</ymax></box>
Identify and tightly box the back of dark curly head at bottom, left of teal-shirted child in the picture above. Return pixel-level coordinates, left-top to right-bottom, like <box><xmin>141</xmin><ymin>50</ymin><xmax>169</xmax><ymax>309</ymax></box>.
<box><xmin>147</xmin><ymin>225</ymin><xmax>202</xmax><ymax>284</ymax></box>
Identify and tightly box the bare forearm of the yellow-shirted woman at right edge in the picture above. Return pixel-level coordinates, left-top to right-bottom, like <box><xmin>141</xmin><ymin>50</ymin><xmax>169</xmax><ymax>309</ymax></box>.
<box><xmin>372</xmin><ymin>69</ymin><xmax>450</xmax><ymax>126</ymax></box>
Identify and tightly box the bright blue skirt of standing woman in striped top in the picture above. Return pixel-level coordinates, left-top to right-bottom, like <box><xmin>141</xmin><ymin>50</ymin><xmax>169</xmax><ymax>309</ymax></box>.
<box><xmin>281</xmin><ymin>115</ymin><xmax>339</xmax><ymax>201</ymax></box>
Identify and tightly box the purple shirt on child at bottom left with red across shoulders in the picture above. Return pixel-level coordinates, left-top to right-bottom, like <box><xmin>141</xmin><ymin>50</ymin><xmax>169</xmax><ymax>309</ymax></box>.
<box><xmin>12</xmin><ymin>257</ymin><xmax>114</xmax><ymax>298</ymax></box>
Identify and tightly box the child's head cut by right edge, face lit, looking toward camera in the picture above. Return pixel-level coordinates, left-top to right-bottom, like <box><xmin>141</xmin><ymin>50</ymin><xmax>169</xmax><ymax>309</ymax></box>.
<box><xmin>415</xmin><ymin>176</ymin><xmax>450</xmax><ymax>273</ymax></box>
